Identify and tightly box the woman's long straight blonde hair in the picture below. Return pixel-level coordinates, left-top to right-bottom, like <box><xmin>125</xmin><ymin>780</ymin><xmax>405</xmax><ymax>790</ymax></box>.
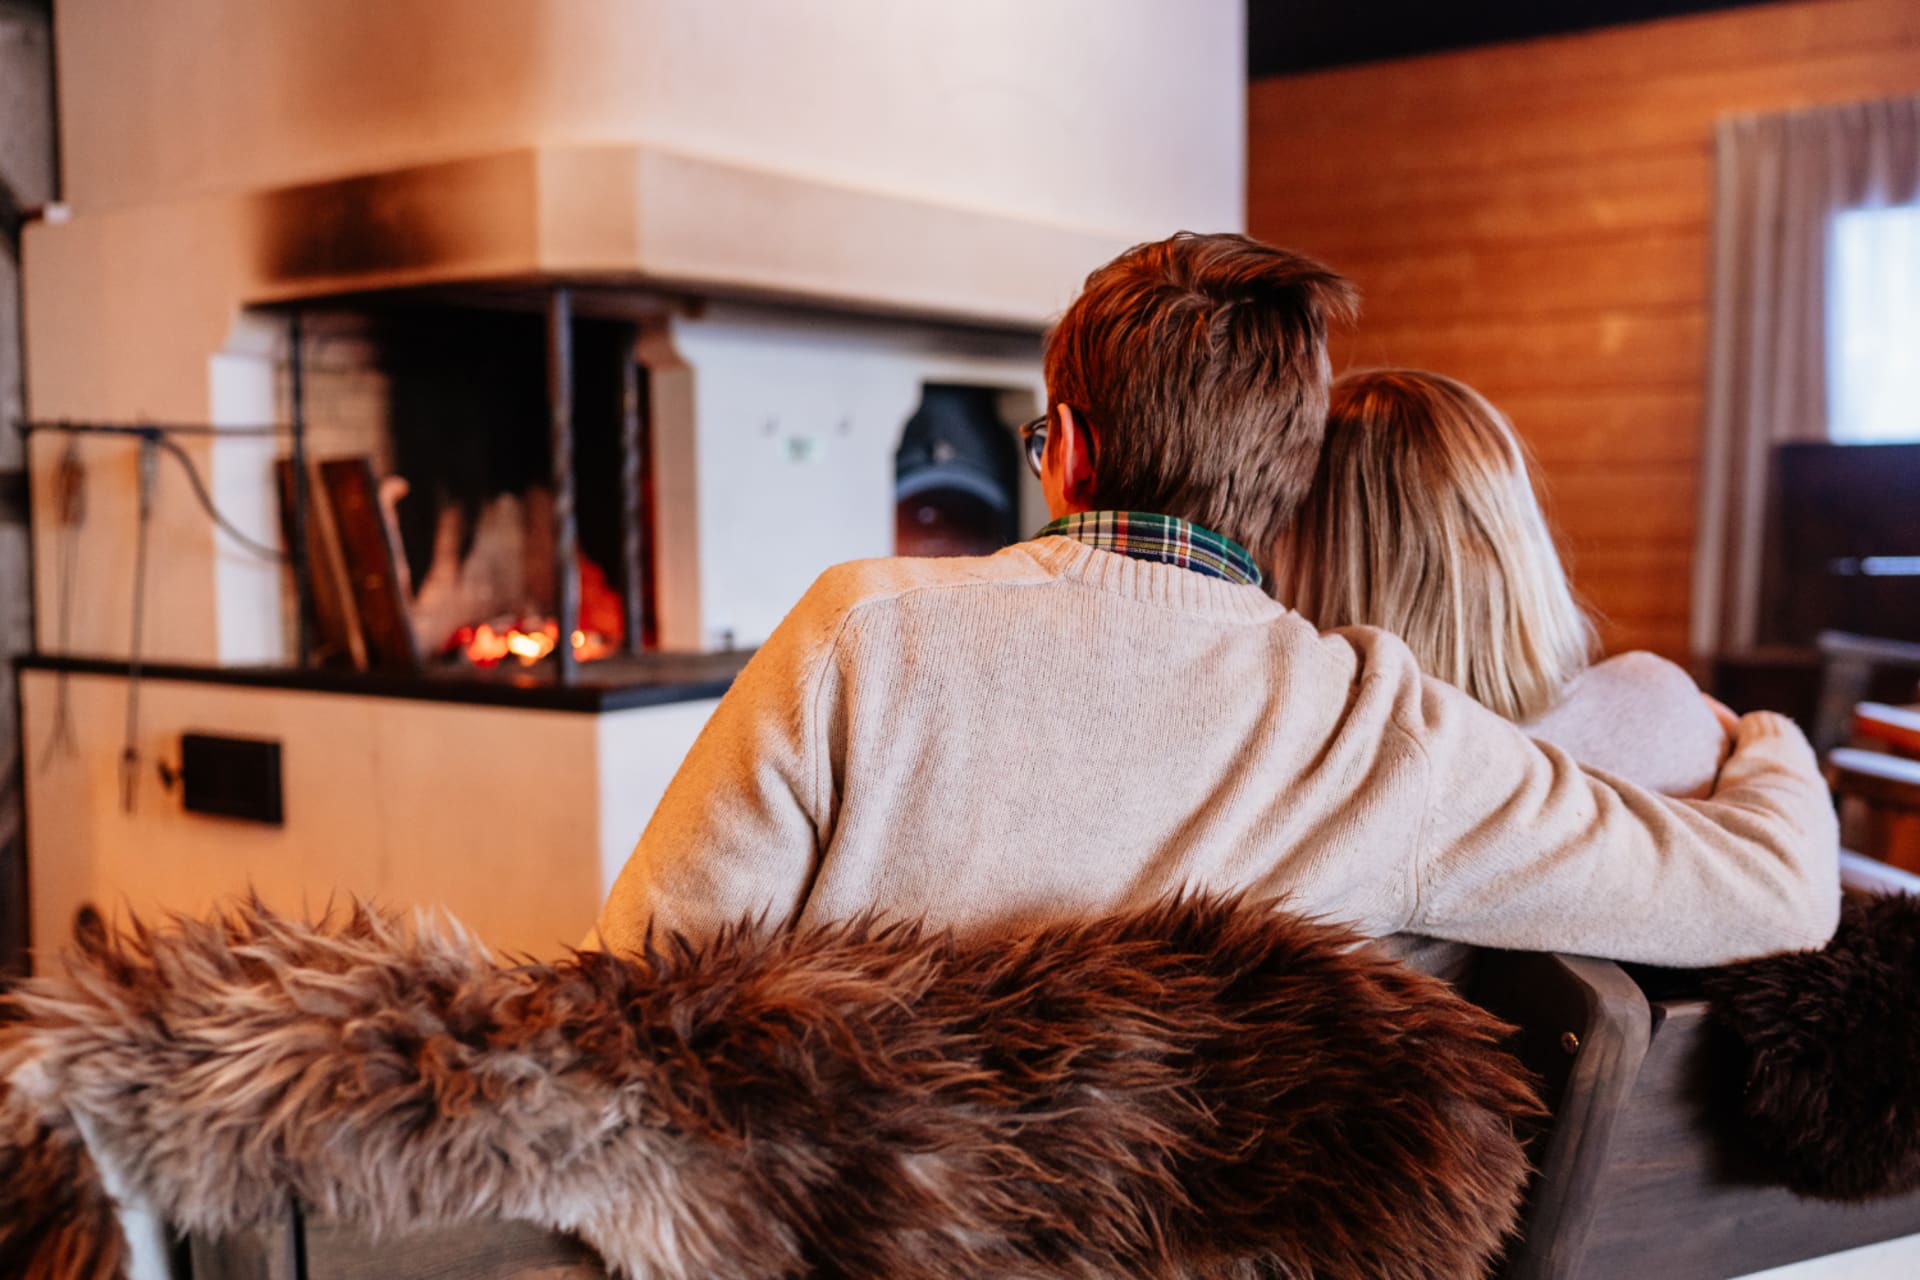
<box><xmin>1275</xmin><ymin>368</ymin><xmax>1596</xmax><ymax>722</ymax></box>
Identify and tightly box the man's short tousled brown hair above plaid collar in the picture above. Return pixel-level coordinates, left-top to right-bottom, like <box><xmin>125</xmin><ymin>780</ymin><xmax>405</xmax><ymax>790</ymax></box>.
<box><xmin>1046</xmin><ymin>230</ymin><xmax>1359</xmax><ymax>568</ymax></box>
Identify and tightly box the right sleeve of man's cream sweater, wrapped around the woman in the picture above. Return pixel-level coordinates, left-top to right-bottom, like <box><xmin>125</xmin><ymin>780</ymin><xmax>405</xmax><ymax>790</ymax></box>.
<box><xmin>1396</xmin><ymin>676</ymin><xmax>1839</xmax><ymax>965</ymax></box>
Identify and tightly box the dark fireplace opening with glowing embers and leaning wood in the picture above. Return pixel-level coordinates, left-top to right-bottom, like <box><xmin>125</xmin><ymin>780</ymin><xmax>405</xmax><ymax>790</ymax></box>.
<box><xmin>282</xmin><ymin>303</ymin><xmax>657</xmax><ymax>668</ymax></box>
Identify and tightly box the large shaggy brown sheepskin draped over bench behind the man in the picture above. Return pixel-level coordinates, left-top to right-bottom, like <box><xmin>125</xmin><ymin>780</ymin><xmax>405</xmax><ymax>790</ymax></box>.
<box><xmin>0</xmin><ymin>898</ymin><xmax>1538</xmax><ymax>1280</ymax></box>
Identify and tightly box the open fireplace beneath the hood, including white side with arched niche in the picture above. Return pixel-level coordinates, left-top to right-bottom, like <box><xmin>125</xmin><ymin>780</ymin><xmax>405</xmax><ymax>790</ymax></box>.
<box><xmin>263</xmin><ymin>297</ymin><xmax>1043</xmax><ymax>683</ymax></box>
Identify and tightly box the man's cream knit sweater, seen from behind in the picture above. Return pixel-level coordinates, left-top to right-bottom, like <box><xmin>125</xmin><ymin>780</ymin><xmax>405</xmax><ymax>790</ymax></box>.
<box><xmin>597</xmin><ymin>537</ymin><xmax>1837</xmax><ymax>965</ymax></box>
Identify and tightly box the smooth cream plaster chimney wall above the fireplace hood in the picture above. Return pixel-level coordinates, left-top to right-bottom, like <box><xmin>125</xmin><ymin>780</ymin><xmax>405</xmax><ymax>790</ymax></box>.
<box><xmin>58</xmin><ymin>0</ymin><xmax>1246</xmax><ymax>238</ymax></box>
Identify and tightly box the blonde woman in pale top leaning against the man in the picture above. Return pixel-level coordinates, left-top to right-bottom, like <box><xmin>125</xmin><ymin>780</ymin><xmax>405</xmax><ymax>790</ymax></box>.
<box><xmin>1275</xmin><ymin>368</ymin><xmax>1726</xmax><ymax>796</ymax></box>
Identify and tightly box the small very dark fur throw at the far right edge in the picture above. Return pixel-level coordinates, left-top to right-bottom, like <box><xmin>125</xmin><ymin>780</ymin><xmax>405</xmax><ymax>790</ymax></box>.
<box><xmin>1705</xmin><ymin>894</ymin><xmax>1920</xmax><ymax>1199</ymax></box>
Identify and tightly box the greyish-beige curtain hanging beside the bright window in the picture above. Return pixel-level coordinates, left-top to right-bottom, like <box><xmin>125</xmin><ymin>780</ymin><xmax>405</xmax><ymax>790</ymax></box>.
<box><xmin>1692</xmin><ymin>98</ymin><xmax>1920</xmax><ymax>654</ymax></box>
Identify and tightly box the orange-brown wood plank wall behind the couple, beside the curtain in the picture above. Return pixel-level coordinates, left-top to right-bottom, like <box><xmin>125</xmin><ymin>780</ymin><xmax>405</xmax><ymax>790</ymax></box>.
<box><xmin>1248</xmin><ymin>0</ymin><xmax>1920</xmax><ymax>658</ymax></box>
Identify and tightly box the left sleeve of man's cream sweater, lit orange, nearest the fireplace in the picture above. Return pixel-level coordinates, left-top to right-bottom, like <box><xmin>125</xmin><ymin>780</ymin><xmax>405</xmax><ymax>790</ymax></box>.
<box><xmin>588</xmin><ymin>578</ymin><xmax>847</xmax><ymax>950</ymax></box>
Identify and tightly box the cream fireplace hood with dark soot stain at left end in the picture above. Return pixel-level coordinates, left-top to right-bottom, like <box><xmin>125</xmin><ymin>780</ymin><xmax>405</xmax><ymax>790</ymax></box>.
<box><xmin>246</xmin><ymin>144</ymin><xmax>1127</xmax><ymax>328</ymax></box>
